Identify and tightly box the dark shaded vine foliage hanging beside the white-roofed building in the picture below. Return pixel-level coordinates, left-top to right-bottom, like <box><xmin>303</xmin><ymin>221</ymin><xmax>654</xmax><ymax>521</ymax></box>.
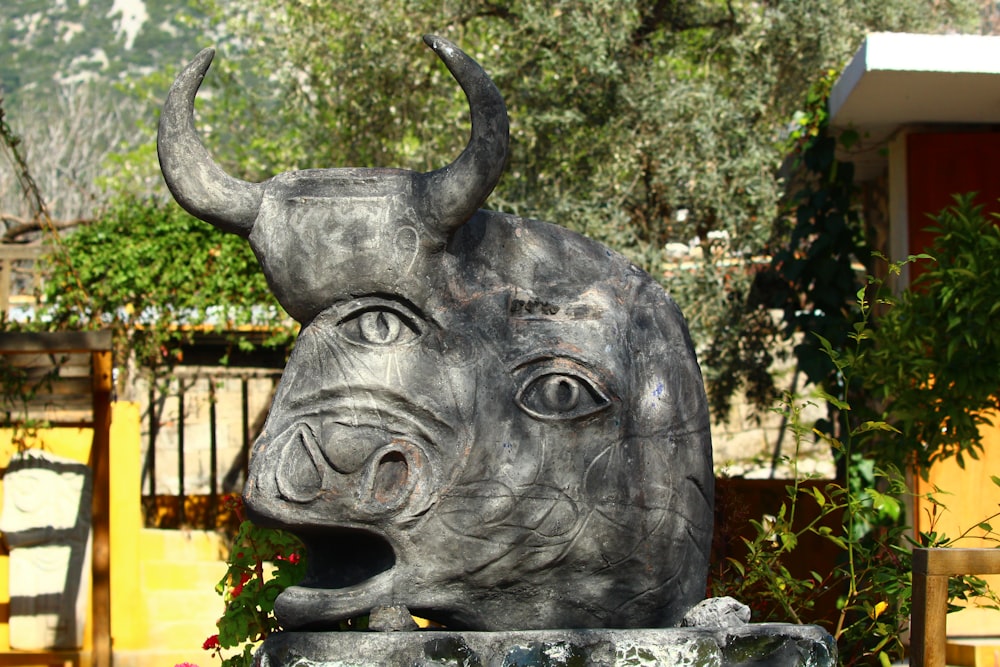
<box><xmin>705</xmin><ymin>69</ymin><xmax>874</xmax><ymax>420</ymax></box>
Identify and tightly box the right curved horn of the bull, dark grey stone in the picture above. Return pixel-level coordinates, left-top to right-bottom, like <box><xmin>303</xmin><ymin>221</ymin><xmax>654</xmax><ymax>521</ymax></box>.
<box><xmin>421</xmin><ymin>35</ymin><xmax>510</xmax><ymax>233</ymax></box>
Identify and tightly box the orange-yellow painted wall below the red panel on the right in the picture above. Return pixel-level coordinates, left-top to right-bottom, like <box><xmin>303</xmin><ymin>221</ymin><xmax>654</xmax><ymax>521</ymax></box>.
<box><xmin>914</xmin><ymin>415</ymin><xmax>1000</xmax><ymax>637</ymax></box>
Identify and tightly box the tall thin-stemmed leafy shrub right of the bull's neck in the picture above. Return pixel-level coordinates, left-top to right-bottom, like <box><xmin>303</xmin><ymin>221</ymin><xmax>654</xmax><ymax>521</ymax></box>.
<box><xmin>712</xmin><ymin>257</ymin><xmax>1000</xmax><ymax>665</ymax></box>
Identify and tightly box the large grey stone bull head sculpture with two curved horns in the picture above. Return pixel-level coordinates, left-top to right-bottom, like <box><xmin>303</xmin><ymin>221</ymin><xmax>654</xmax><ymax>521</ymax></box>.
<box><xmin>158</xmin><ymin>37</ymin><xmax>713</xmax><ymax>630</ymax></box>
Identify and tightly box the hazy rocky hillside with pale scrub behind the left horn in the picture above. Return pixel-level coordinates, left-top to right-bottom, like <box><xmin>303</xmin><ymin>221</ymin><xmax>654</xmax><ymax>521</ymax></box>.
<box><xmin>0</xmin><ymin>0</ymin><xmax>209</xmax><ymax>226</ymax></box>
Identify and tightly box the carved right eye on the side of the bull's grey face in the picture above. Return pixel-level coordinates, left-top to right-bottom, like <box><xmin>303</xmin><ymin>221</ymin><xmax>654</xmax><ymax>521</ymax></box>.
<box><xmin>514</xmin><ymin>364</ymin><xmax>611</xmax><ymax>420</ymax></box>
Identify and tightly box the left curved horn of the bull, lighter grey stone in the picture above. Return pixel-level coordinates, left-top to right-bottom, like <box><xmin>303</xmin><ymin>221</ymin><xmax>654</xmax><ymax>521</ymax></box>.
<box><xmin>156</xmin><ymin>49</ymin><xmax>264</xmax><ymax>237</ymax></box>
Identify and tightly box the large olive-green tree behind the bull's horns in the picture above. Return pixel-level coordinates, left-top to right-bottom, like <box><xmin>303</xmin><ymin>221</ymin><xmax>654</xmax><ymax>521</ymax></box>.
<box><xmin>174</xmin><ymin>0</ymin><xmax>976</xmax><ymax>417</ymax></box>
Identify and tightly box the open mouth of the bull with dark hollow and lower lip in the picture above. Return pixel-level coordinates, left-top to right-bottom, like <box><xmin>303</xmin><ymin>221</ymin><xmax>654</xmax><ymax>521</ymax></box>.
<box><xmin>274</xmin><ymin>528</ymin><xmax>396</xmax><ymax>630</ymax></box>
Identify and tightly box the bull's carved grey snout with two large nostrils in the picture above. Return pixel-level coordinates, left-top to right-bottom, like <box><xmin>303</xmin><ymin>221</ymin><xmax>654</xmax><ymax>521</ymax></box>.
<box><xmin>270</xmin><ymin>424</ymin><xmax>433</xmax><ymax>521</ymax></box>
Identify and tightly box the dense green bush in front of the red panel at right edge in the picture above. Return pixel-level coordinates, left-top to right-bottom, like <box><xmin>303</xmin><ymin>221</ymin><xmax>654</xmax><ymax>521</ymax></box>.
<box><xmin>865</xmin><ymin>194</ymin><xmax>1000</xmax><ymax>472</ymax></box>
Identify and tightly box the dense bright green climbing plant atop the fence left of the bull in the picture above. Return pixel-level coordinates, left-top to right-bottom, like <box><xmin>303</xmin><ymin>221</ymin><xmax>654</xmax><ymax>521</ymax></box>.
<box><xmin>36</xmin><ymin>195</ymin><xmax>297</xmax><ymax>386</ymax></box>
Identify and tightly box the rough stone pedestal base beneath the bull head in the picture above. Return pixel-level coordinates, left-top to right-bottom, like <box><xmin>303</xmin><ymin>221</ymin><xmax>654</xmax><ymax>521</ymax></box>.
<box><xmin>257</xmin><ymin>623</ymin><xmax>837</xmax><ymax>667</ymax></box>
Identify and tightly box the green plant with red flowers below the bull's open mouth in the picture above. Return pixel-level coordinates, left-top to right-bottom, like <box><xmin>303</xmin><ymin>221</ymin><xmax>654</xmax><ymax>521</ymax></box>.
<box><xmin>202</xmin><ymin>497</ymin><xmax>306</xmax><ymax>667</ymax></box>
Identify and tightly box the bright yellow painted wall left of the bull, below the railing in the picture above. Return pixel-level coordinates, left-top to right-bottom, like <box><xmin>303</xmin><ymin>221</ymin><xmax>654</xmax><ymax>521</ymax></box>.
<box><xmin>0</xmin><ymin>402</ymin><xmax>228</xmax><ymax>667</ymax></box>
